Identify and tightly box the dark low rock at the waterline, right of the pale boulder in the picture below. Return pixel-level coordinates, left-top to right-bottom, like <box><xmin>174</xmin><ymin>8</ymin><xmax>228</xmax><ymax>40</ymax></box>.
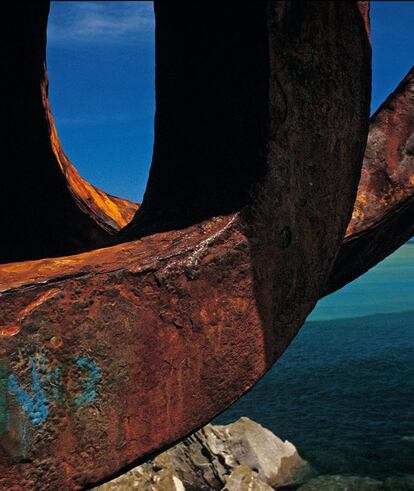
<box><xmin>298</xmin><ymin>476</ymin><xmax>382</xmax><ymax>491</ymax></box>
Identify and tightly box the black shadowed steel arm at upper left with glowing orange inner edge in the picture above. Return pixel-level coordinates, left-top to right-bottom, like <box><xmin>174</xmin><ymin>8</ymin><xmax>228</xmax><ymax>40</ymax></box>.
<box><xmin>0</xmin><ymin>2</ymin><xmax>136</xmax><ymax>263</ymax></box>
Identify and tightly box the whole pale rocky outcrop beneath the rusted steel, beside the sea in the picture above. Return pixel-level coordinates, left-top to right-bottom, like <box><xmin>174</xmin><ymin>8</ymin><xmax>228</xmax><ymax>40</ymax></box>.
<box><xmin>96</xmin><ymin>418</ymin><xmax>314</xmax><ymax>491</ymax></box>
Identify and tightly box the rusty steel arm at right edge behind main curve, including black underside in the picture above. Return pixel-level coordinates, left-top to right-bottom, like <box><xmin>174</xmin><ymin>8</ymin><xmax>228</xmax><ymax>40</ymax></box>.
<box><xmin>325</xmin><ymin>67</ymin><xmax>414</xmax><ymax>294</ymax></box>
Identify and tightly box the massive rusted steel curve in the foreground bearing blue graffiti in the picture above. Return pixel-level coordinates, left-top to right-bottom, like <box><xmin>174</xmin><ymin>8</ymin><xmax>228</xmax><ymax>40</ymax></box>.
<box><xmin>0</xmin><ymin>1</ymin><xmax>410</xmax><ymax>490</ymax></box>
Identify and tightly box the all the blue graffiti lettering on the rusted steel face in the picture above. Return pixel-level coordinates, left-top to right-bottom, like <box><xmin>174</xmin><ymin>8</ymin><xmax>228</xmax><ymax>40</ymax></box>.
<box><xmin>3</xmin><ymin>353</ymin><xmax>101</xmax><ymax>426</ymax></box>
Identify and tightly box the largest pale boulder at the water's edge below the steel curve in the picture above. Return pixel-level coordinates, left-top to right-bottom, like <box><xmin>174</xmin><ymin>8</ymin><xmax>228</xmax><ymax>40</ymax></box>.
<box><xmin>168</xmin><ymin>418</ymin><xmax>312</xmax><ymax>489</ymax></box>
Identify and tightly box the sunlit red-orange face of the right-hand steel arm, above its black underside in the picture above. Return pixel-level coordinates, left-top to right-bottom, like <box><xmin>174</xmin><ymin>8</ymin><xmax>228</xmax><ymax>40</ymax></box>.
<box><xmin>346</xmin><ymin>67</ymin><xmax>414</xmax><ymax>238</ymax></box>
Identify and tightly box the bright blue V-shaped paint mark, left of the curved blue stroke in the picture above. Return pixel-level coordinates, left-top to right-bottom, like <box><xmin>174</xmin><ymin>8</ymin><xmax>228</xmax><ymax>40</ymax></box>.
<box><xmin>9</xmin><ymin>357</ymin><xmax>49</xmax><ymax>426</ymax></box>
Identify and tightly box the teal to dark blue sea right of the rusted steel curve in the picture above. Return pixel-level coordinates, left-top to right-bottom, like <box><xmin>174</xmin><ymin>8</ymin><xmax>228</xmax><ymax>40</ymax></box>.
<box><xmin>214</xmin><ymin>242</ymin><xmax>414</xmax><ymax>478</ymax></box>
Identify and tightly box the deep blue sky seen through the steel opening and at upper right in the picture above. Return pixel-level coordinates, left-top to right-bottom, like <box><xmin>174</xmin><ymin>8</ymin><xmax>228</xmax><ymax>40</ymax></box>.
<box><xmin>47</xmin><ymin>1</ymin><xmax>414</xmax><ymax>201</ymax></box>
